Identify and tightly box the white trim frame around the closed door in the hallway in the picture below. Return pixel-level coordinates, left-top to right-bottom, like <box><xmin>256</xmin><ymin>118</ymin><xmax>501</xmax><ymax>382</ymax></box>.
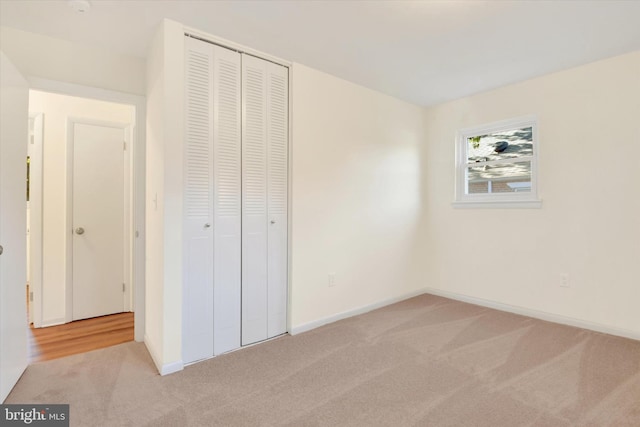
<box><xmin>65</xmin><ymin>117</ymin><xmax>135</xmax><ymax>324</ymax></box>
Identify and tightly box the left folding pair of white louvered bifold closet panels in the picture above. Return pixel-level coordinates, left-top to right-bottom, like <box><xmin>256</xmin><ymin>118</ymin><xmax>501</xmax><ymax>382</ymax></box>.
<box><xmin>183</xmin><ymin>37</ymin><xmax>241</xmax><ymax>363</ymax></box>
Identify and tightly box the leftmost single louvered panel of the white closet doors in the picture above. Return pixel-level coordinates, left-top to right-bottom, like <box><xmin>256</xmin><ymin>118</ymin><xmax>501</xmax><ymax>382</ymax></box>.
<box><xmin>184</xmin><ymin>38</ymin><xmax>213</xmax><ymax>363</ymax></box>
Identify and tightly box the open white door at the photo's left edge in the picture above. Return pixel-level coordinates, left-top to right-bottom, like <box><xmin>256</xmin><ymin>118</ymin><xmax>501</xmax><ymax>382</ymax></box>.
<box><xmin>0</xmin><ymin>52</ymin><xmax>29</xmax><ymax>402</ymax></box>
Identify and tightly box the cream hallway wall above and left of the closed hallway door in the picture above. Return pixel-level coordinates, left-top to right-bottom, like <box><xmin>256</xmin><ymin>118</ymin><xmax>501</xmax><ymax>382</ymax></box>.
<box><xmin>25</xmin><ymin>91</ymin><xmax>135</xmax><ymax>326</ymax></box>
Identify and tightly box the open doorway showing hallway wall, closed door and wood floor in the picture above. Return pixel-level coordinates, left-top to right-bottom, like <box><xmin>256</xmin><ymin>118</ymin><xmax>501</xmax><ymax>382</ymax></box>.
<box><xmin>27</xmin><ymin>90</ymin><xmax>142</xmax><ymax>362</ymax></box>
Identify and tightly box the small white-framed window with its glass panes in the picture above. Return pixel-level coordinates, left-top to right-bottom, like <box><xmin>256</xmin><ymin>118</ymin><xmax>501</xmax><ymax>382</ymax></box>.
<box><xmin>454</xmin><ymin>113</ymin><xmax>541</xmax><ymax>208</ymax></box>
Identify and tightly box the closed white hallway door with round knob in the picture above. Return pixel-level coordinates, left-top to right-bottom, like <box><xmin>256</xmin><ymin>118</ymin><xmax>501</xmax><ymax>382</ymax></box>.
<box><xmin>70</xmin><ymin>121</ymin><xmax>126</xmax><ymax>320</ymax></box>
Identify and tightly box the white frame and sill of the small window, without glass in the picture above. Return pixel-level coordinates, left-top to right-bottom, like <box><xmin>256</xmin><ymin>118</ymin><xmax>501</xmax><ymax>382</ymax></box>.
<box><xmin>453</xmin><ymin>115</ymin><xmax>542</xmax><ymax>208</ymax></box>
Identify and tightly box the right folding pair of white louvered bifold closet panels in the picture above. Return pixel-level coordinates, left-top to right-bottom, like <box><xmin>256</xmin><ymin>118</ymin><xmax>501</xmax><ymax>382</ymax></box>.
<box><xmin>242</xmin><ymin>54</ymin><xmax>289</xmax><ymax>345</ymax></box>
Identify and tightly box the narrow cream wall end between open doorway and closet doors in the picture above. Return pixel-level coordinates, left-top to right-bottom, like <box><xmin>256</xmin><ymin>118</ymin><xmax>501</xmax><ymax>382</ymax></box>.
<box><xmin>145</xmin><ymin>20</ymin><xmax>184</xmax><ymax>374</ymax></box>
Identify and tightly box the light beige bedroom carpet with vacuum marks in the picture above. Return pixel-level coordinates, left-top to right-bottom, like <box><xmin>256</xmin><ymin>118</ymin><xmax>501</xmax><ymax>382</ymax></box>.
<box><xmin>6</xmin><ymin>295</ymin><xmax>640</xmax><ymax>427</ymax></box>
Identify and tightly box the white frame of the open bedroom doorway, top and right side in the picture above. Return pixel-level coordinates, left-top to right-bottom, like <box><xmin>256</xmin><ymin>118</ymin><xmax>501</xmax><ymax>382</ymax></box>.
<box><xmin>26</xmin><ymin>76</ymin><xmax>146</xmax><ymax>342</ymax></box>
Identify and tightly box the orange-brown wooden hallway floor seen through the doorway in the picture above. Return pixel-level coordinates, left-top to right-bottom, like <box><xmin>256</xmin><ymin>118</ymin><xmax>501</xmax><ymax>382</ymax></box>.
<box><xmin>29</xmin><ymin>313</ymin><xmax>133</xmax><ymax>363</ymax></box>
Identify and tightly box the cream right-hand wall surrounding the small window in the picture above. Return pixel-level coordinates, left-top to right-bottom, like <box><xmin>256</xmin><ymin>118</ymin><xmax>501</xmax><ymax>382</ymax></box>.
<box><xmin>421</xmin><ymin>52</ymin><xmax>640</xmax><ymax>336</ymax></box>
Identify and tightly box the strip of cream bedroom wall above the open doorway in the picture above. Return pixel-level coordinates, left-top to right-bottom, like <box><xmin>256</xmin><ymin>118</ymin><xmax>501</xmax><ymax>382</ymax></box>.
<box><xmin>0</xmin><ymin>27</ymin><xmax>146</xmax><ymax>95</ymax></box>
